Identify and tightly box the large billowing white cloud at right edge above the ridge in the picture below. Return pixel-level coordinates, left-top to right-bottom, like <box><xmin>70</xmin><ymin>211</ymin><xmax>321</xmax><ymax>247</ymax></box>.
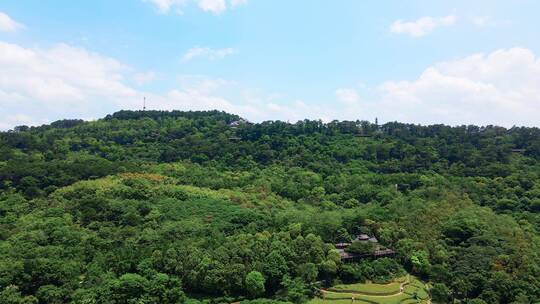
<box><xmin>373</xmin><ymin>48</ymin><xmax>540</xmax><ymax>126</ymax></box>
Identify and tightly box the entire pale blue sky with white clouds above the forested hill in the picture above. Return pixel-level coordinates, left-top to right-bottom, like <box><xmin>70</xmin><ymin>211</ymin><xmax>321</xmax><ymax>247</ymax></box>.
<box><xmin>0</xmin><ymin>0</ymin><xmax>540</xmax><ymax>130</ymax></box>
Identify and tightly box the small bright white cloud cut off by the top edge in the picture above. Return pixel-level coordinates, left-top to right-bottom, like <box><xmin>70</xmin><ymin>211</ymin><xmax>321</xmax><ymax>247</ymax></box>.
<box><xmin>144</xmin><ymin>0</ymin><xmax>248</xmax><ymax>15</ymax></box>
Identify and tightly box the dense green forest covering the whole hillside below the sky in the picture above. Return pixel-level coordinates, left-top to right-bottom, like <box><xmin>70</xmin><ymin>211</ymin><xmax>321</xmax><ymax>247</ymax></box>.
<box><xmin>0</xmin><ymin>111</ymin><xmax>540</xmax><ymax>304</ymax></box>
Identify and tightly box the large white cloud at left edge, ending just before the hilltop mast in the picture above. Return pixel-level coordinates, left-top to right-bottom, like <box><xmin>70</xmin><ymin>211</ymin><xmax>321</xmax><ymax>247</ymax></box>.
<box><xmin>0</xmin><ymin>42</ymin><xmax>140</xmax><ymax>128</ymax></box>
